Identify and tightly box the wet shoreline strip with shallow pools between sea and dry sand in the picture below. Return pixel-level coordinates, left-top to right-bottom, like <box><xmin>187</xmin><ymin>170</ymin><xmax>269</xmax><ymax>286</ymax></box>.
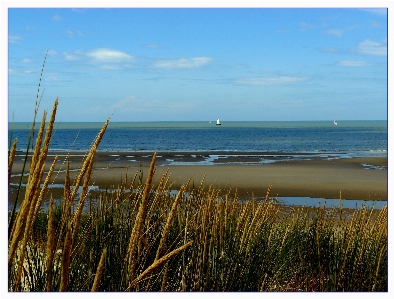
<box><xmin>15</xmin><ymin>150</ymin><xmax>387</xmax><ymax>168</ymax></box>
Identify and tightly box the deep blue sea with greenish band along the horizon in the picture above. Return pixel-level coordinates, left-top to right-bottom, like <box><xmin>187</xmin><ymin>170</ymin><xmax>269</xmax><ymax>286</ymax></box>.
<box><xmin>8</xmin><ymin>121</ymin><xmax>388</xmax><ymax>156</ymax></box>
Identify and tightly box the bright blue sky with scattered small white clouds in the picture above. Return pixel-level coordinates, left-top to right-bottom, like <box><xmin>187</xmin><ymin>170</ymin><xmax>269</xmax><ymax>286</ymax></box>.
<box><xmin>8</xmin><ymin>8</ymin><xmax>388</xmax><ymax>122</ymax></box>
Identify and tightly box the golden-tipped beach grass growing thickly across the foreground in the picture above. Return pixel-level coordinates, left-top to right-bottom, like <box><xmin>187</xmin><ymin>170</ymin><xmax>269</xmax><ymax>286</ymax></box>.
<box><xmin>8</xmin><ymin>100</ymin><xmax>388</xmax><ymax>292</ymax></box>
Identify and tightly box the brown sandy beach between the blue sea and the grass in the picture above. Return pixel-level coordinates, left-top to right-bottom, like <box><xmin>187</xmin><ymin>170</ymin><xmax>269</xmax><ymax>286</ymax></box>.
<box><xmin>11</xmin><ymin>152</ymin><xmax>388</xmax><ymax>200</ymax></box>
